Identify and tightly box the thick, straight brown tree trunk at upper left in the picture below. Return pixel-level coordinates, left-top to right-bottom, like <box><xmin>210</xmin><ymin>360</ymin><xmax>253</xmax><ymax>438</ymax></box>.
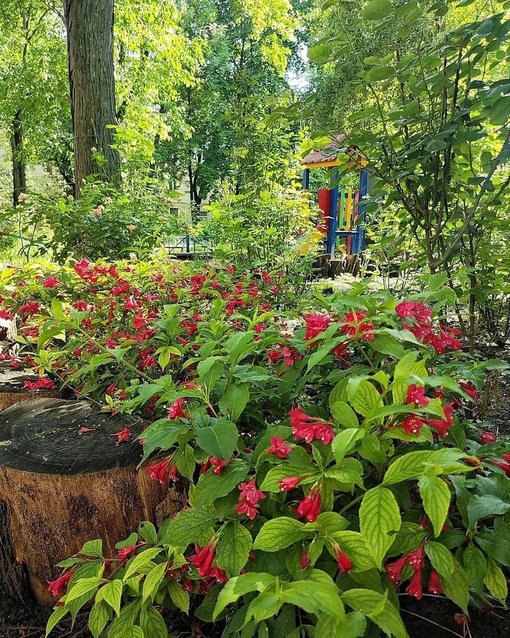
<box><xmin>63</xmin><ymin>0</ymin><xmax>120</xmax><ymax>196</ymax></box>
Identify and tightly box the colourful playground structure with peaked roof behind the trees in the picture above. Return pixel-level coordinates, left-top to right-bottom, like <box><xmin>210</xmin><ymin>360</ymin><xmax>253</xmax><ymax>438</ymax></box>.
<box><xmin>302</xmin><ymin>134</ymin><xmax>368</xmax><ymax>259</ymax></box>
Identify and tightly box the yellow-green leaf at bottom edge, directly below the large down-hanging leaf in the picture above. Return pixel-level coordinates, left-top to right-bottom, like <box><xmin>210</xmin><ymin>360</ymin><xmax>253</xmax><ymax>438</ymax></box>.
<box><xmin>341</xmin><ymin>589</ymin><xmax>409</xmax><ymax>638</ymax></box>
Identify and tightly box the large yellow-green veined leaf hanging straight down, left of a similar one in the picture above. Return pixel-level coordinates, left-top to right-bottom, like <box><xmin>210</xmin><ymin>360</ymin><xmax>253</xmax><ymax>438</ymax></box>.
<box><xmin>359</xmin><ymin>486</ymin><xmax>402</xmax><ymax>568</ymax></box>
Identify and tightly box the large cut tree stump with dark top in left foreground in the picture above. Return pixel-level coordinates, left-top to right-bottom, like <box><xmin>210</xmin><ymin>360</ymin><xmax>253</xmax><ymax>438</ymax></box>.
<box><xmin>0</xmin><ymin>399</ymin><xmax>184</xmax><ymax>605</ymax></box>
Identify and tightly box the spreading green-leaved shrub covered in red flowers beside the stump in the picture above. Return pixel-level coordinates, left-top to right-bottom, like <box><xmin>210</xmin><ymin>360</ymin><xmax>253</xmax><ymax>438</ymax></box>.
<box><xmin>2</xmin><ymin>263</ymin><xmax>510</xmax><ymax>638</ymax></box>
